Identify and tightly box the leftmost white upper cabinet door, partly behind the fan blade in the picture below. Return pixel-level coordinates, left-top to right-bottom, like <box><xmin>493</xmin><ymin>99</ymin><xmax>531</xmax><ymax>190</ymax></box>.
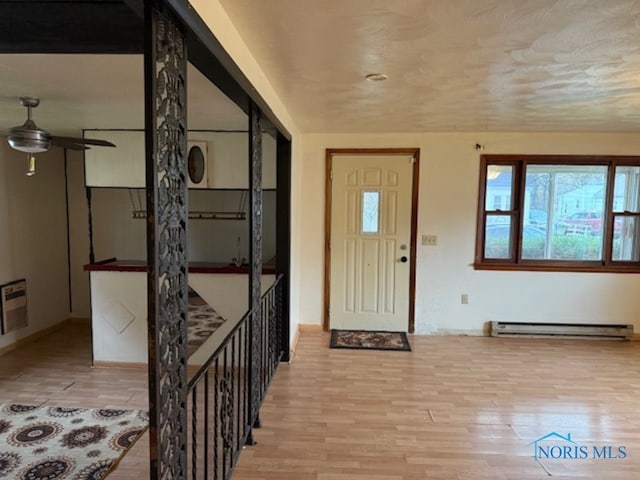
<box><xmin>84</xmin><ymin>130</ymin><xmax>145</xmax><ymax>188</ymax></box>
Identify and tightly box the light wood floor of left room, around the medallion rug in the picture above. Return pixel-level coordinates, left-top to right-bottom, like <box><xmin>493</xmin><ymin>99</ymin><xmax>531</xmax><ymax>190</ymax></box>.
<box><xmin>0</xmin><ymin>323</ymin><xmax>149</xmax><ymax>480</ymax></box>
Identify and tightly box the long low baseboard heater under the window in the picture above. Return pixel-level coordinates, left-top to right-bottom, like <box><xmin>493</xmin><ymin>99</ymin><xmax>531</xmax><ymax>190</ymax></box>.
<box><xmin>491</xmin><ymin>322</ymin><xmax>633</xmax><ymax>340</ymax></box>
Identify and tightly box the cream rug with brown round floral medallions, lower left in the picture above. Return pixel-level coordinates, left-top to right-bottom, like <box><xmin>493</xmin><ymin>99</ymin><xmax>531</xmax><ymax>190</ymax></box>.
<box><xmin>0</xmin><ymin>404</ymin><xmax>149</xmax><ymax>480</ymax></box>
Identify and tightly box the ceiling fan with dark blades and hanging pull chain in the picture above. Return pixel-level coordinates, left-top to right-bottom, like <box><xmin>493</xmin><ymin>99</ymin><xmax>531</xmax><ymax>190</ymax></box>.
<box><xmin>0</xmin><ymin>97</ymin><xmax>115</xmax><ymax>176</ymax></box>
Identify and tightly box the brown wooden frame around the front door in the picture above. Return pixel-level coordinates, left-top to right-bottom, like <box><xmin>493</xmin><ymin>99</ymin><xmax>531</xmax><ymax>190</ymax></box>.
<box><xmin>322</xmin><ymin>148</ymin><xmax>420</xmax><ymax>333</ymax></box>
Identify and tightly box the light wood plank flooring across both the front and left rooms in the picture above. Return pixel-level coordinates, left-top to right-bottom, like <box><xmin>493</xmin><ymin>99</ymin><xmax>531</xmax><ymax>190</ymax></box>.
<box><xmin>0</xmin><ymin>325</ymin><xmax>640</xmax><ymax>480</ymax></box>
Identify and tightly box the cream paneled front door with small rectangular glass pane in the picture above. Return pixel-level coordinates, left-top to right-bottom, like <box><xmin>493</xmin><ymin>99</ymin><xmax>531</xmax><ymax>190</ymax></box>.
<box><xmin>329</xmin><ymin>154</ymin><xmax>413</xmax><ymax>331</ymax></box>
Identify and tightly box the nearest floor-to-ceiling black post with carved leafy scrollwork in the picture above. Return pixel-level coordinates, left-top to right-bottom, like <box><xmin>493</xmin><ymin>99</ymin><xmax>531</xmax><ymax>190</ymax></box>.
<box><xmin>145</xmin><ymin>2</ymin><xmax>188</xmax><ymax>480</ymax></box>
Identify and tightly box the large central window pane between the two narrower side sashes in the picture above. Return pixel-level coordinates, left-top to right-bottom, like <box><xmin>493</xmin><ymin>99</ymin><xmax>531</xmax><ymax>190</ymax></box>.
<box><xmin>522</xmin><ymin>165</ymin><xmax>607</xmax><ymax>261</ymax></box>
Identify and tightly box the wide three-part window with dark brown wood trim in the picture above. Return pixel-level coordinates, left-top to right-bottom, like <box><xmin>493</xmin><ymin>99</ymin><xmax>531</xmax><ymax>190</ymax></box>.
<box><xmin>475</xmin><ymin>155</ymin><xmax>640</xmax><ymax>272</ymax></box>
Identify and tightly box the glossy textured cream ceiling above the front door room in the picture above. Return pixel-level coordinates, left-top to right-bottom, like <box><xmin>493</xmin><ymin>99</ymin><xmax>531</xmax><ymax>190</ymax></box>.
<box><xmin>220</xmin><ymin>0</ymin><xmax>640</xmax><ymax>132</ymax></box>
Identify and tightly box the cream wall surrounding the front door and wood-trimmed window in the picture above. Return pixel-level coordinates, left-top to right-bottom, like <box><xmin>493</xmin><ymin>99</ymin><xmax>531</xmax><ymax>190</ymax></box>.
<box><xmin>294</xmin><ymin>133</ymin><xmax>640</xmax><ymax>334</ymax></box>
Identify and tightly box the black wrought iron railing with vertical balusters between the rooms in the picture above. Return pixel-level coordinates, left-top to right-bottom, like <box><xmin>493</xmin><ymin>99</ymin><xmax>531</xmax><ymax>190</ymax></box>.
<box><xmin>187</xmin><ymin>275</ymin><xmax>284</xmax><ymax>480</ymax></box>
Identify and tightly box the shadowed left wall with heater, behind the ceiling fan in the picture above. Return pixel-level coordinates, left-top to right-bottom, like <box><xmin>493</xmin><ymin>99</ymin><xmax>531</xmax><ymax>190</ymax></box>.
<box><xmin>0</xmin><ymin>142</ymin><xmax>69</xmax><ymax>348</ymax></box>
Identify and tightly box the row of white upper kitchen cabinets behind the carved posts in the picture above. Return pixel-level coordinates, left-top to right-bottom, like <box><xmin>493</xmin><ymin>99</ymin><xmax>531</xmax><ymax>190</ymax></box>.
<box><xmin>85</xmin><ymin>130</ymin><xmax>276</xmax><ymax>189</ymax></box>
